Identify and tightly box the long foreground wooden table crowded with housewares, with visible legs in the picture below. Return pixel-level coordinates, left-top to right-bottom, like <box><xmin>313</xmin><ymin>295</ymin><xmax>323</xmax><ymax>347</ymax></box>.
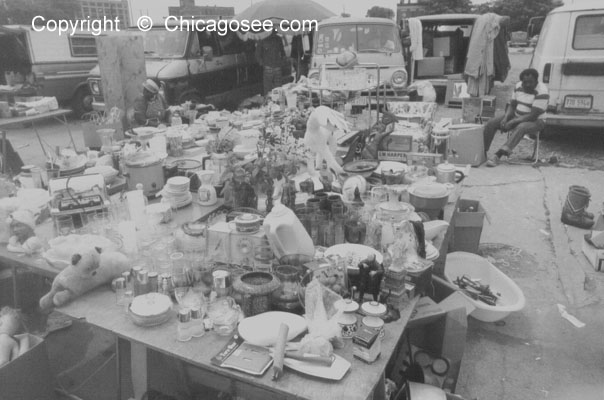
<box><xmin>0</xmin><ymin>183</ymin><xmax>461</xmax><ymax>400</ymax></box>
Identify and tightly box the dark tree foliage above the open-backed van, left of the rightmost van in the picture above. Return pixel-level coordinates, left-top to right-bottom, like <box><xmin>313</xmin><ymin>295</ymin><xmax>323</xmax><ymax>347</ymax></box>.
<box><xmin>474</xmin><ymin>0</ymin><xmax>562</xmax><ymax>32</ymax></box>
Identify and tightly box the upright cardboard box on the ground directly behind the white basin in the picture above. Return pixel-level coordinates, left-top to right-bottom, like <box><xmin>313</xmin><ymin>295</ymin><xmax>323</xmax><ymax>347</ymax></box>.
<box><xmin>453</xmin><ymin>199</ymin><xmax>485</xmax><ymax>254</ymax></box>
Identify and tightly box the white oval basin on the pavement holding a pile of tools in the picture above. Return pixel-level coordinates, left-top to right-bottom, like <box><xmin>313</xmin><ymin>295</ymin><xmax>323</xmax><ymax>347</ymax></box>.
<box><xmin>445</xmin><ymin>251</ymin><xmax>526</xmax><ymax>322</ymax></box>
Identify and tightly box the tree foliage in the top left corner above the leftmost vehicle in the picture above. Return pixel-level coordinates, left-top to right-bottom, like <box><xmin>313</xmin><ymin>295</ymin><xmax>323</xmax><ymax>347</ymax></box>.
<box><xmin>0</xmin><ymin>0</ymin><xmax>81</xmax><ymax>25</ymax></box>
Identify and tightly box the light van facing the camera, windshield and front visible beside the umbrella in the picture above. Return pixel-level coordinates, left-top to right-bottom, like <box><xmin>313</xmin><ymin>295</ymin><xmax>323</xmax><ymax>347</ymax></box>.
<box><xmin>308</xmin><ymin>17</ymin><xmax>407</xmax><ymax>93</ymax></box>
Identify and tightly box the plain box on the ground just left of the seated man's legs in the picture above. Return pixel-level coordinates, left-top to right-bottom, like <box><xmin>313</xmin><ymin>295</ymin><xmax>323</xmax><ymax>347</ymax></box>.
<box><xmin>449</xmin><ymin>124</ymin><xmax>487</xmax><ymax>167</ymax></box>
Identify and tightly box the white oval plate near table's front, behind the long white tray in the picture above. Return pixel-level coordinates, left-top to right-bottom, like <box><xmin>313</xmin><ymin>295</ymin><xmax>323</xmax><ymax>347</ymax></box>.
<box><xmin>239</xmin><ymin>311</ymin><xmax>306</xmax><ymax>346</ymax></box>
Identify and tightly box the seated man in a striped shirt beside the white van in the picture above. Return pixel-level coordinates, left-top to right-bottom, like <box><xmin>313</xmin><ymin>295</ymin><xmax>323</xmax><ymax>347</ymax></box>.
<box><xmin>484</xmin><ymin>68</ymin><xmax>549</xmax><ymax>167</ymax></box>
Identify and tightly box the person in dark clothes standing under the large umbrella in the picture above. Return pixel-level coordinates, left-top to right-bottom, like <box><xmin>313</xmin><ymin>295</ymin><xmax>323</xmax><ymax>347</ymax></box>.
<box><xmin>256</xmin><ymin>30</ymin><xmax>285</xmax><ymax>96</ymax></box>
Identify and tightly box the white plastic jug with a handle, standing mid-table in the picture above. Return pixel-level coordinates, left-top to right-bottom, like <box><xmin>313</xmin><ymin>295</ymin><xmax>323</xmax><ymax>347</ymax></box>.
<box><xmin>263</xmin><ymin>204</ymin><xmax>315</xmax><ymax>259</ymax></box>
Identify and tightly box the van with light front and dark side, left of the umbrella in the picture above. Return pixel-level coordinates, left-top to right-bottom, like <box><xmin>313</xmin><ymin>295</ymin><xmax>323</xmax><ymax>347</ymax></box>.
<box><xmin>88</xmin><ymin>25</ymin><xmax>284</xmax><ymax>111</ymax></box>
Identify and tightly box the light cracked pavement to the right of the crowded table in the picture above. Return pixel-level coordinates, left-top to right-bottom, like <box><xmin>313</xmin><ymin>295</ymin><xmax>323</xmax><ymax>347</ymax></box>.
<box><xmin>457</xmin><ymin>163</ymin><xmax>604</xmax><ymax>400</ymax></box>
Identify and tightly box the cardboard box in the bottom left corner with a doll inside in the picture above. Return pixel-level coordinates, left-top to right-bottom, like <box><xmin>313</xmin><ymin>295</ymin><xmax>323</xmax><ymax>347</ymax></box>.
<box><xmin>0</xmin><ymin>335</ymin><xmax>56</xmax><ymax>400</ymax></box>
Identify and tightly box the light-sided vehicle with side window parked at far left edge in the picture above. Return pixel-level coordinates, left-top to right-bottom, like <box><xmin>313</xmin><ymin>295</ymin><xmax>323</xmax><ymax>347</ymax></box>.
<box><xmin>0</xmin><ymin>25</ymin><xmax>97</xmax><ymax>115</ymax></box>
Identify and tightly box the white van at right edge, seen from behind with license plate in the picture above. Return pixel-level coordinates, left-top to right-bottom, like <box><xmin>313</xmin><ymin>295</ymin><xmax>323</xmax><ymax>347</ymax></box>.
<box><xmin>530</xmin><ymin>0</ymin><xmax>604</xmax><ymax>128</ymax></box>
